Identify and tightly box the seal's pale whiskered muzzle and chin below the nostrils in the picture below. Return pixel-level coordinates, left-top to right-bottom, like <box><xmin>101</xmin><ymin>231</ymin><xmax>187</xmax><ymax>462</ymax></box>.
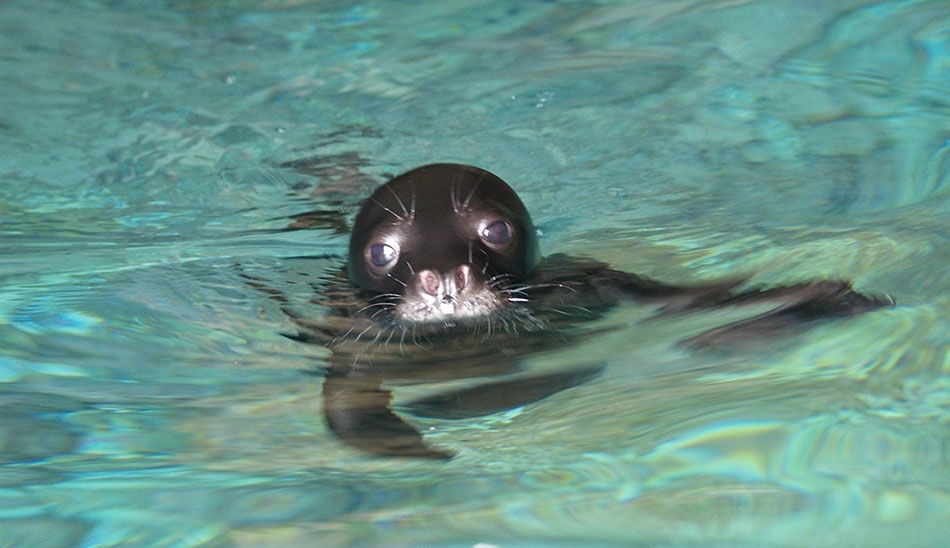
<box><xmin>396</xmin><ymin>287</ymin><xmax>505</xmax><ymax>323</ymax></box>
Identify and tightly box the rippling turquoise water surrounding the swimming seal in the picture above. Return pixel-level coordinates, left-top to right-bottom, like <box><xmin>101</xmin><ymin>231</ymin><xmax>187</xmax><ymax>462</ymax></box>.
<box><xmin>0</xmin><ymin>0</ymin><xmax>950</xmax><ymax>547</ymax></box>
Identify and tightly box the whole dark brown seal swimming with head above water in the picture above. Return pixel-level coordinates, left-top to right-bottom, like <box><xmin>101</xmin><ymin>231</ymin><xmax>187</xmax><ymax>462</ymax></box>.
<box><xmin>255</xmin><ymin>164</ymin><xmax>893</xmax><ymax>458</ymax></box>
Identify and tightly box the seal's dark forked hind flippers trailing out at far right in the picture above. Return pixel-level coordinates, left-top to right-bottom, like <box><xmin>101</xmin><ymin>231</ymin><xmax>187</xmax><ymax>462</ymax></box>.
<box><xmin>683</xmin><ymin>281</ymin><xmax>894</xmax><ymax>349</ymax></box>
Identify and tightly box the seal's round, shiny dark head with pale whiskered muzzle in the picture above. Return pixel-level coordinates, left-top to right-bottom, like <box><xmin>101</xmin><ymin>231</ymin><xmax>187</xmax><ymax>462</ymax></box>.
<box><xmin>348</xmin><ymin>164</ymin><xmax>540</xmax><ymax>322</ymax></box>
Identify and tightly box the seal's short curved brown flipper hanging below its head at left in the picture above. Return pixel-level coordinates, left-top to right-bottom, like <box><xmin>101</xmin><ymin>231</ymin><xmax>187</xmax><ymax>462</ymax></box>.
<box><xmin>323</xmin><ymin>371</ymin><xmax>453</xmax><ymax>459</ymax></box>
